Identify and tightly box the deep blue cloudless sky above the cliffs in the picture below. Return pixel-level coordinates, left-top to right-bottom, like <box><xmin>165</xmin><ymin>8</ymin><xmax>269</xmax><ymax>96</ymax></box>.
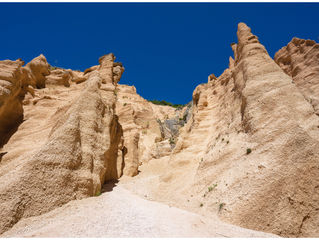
<box><xmin>0</xmin><ymin>3</ymin><xmax>319</xmax><ymax>104</ymax></box>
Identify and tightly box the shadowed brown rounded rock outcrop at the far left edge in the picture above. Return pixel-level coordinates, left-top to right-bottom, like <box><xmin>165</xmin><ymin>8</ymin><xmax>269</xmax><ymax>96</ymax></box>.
<box><xmin>0</xmin><ymin>55</ymin><xmax>50</xmax><ymax>147</ymax></box>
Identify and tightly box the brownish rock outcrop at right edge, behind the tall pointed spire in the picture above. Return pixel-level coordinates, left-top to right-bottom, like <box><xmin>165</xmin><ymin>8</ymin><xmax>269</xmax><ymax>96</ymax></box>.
<box><xmin>275</xmin><ymin>38</ymin><xmax>319</xmax><ymax>115</ymax></box>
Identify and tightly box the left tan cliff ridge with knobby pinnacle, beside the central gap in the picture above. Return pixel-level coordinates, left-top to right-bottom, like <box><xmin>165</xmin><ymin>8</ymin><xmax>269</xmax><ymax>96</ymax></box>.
<box><xmin>0</xmin><ymin>54</ymin><xmax>122</xmax><ymax>233</ymax></box>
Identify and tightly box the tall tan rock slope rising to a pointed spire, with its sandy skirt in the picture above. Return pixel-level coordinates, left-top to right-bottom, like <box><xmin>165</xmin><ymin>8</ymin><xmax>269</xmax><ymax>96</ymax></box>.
<box><xmin>120</xmin><ymin>23</ymin><xmax>319</xmax><ymax>237</ymax></box>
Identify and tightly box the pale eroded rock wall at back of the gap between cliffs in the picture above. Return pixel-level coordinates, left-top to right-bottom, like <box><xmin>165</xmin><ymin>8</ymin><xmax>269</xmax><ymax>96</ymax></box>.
<box><xmin>116</xmin><ymin>85</ymin><xmax>178</xmax><ymax>176</ymax></box>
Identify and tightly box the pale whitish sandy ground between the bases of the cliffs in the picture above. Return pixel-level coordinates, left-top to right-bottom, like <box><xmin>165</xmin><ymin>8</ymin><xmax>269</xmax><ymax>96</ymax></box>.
<box><xmin>2</xmin><ymin>184</ymin><xmax>275</xmax><ymax>237</ymax></box>
